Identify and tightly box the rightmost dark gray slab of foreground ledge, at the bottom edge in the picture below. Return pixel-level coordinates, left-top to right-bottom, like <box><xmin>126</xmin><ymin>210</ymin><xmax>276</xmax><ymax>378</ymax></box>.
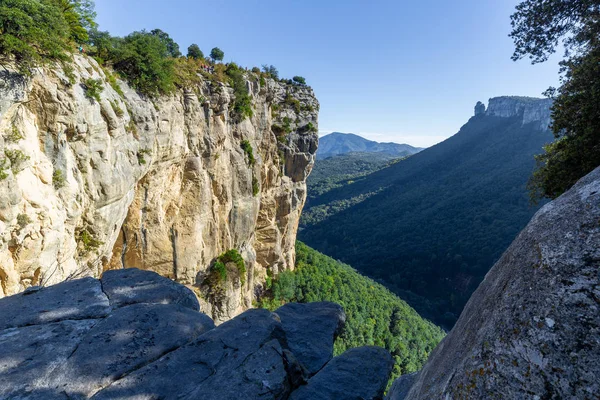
<box><xmin>290</xmin><ymin>346</ymin><xmax>394</xmax><ymax>400</ymax></box>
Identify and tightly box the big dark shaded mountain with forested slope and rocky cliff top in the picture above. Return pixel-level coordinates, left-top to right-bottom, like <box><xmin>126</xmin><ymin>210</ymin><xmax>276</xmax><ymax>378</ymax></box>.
<box><xmin>299</xmin><ymin>97</ymin><xmax>553</xmax><ymax>328</ymax></box>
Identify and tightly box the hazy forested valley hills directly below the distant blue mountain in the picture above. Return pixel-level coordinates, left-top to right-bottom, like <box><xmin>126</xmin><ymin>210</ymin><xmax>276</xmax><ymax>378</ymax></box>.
<box><xmin>300</xmin><ymin>152</ymin><xmax>405</xmax><ymax>229</ymax></box>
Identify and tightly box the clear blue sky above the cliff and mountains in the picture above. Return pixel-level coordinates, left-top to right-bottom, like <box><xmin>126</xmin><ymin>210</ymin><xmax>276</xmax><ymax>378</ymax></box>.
<box><xmin>96</xmin><ymin>0</ymin><xmax>558</xmax><ymax>146</ymax></box>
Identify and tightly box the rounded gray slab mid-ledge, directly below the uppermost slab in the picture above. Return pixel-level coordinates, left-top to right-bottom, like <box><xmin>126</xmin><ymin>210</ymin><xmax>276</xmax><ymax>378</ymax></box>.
<box><xmin>50</xmin><ymin>304</ymin><xmax>214</xmax><ymax>399</ymax></box>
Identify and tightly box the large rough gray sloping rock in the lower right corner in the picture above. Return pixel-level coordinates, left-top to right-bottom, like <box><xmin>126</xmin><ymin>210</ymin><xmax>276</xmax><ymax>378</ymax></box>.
<box><xmin>390</xmin><ymin>168</ymin><xmax>600</xmax><ymax>399</ymax></box>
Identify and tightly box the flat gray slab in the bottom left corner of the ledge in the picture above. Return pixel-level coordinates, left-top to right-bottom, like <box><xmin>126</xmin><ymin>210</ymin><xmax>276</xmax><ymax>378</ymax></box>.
<box><xmin>0</xmin><ymin>319</ymin><xmax>98</xmax><ymax>399</ymax></box>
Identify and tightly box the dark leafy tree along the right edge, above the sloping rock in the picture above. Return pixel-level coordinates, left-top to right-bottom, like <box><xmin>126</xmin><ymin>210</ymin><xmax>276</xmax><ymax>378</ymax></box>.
<box><xmin>510</xmin><ymin>0</ymin><xmax>600</xmax><ymax>199</ymax></box>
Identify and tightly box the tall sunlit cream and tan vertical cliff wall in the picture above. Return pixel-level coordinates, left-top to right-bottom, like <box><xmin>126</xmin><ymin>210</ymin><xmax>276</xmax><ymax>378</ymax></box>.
<box><xmin>0</xmin><ymin>55</ymin><xmax>319</xmax><ymax>321</ymax></box>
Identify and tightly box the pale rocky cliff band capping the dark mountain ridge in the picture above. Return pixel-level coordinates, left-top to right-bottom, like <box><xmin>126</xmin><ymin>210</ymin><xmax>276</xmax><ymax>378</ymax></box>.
<box><xmin>475</xmin><ymin>96</ymin><xmax>552</xmax><ymax>130</ymax></box>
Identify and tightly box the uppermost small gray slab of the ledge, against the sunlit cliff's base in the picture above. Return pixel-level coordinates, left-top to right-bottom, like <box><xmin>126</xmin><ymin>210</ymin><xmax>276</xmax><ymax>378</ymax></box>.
<box><xmin>100</xmin><ymin>268</ymin><xmax>200</xmax><ymax>311</ymax></box>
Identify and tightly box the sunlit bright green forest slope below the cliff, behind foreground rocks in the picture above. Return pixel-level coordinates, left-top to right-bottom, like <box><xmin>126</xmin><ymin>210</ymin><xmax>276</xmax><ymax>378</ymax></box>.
<box><xmin>260</xmin><ymin>242</ymin><xmax>444</xmax><ymax>383</ymax></box>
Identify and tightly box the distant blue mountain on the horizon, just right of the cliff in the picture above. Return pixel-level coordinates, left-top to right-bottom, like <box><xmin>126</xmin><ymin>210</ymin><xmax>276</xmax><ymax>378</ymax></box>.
<box><xmin>317</xmin><ymin>132</ymin><xmax>422</xmax><ymax>159</ymax></box>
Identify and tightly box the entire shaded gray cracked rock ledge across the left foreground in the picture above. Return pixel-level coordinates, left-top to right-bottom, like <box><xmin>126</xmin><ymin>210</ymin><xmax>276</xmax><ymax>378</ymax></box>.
<box><xmin>0</xmin><ymin>270</ymin><xmax>392</xmax><ymax>400</ymax></box>
